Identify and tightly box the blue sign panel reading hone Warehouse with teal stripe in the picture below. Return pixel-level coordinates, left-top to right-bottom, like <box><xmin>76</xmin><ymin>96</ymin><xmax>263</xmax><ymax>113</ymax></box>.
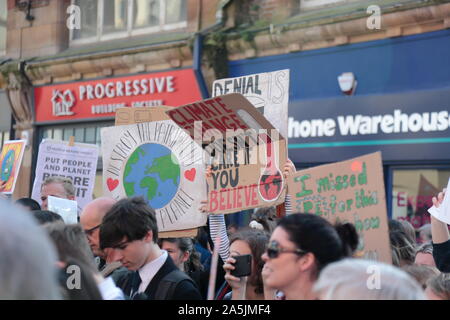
<box><xmin>289</xmin><ymin>88</ymin><xmax>450</xmax><ymax>163</ymax></box>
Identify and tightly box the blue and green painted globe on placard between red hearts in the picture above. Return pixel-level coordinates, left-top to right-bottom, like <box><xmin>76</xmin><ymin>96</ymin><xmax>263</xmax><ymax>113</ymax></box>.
<box><xmin>123</xmin><ymin>143</ymin><xmax>180</xmax><ymax>209</ymax></box>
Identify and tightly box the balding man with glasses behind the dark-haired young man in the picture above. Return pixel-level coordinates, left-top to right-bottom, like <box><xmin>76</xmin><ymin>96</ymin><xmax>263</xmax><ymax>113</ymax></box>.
<box><xmin>80</xmin><ymin>197</ymin><xmax>127</xmax><ymax>282</ymax></box>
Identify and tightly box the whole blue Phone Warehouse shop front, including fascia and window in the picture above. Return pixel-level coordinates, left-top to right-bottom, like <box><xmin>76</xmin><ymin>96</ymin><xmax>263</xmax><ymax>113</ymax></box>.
<box><xmin>229</xmin><ymin>30</ymin><xmax>450</xmax><ymax>228</ymax></box>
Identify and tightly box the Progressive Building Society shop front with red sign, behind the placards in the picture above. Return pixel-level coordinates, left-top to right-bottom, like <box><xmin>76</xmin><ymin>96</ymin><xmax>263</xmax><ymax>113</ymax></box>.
<box><xmin>32</xmin><ymin>68</ymin><xmax>203</xmax><ymax>198</ymax></box>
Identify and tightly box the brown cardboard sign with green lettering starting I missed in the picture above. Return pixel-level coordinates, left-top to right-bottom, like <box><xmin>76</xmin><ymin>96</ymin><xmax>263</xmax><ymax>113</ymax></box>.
<box><xmin>287</xmin><ymin>152</ymin><xmax>392</xmax><ymax>263</ymax></box>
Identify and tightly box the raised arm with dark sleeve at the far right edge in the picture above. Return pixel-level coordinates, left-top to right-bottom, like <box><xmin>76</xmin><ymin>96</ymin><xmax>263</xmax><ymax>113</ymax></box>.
<box><xmin>431</xmin><ymin>189</ymin><xmax>450</xmax><ymax>272</ymax></box>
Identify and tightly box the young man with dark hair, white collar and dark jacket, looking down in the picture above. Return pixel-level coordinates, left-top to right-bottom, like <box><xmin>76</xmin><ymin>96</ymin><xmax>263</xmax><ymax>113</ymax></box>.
<box><xmin>100</xmin><ymin>197</ymin><xmax>201</xmax><ymax>300</ymax></box>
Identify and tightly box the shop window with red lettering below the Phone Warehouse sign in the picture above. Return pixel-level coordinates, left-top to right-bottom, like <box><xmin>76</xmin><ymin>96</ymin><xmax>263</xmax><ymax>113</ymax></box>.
<box><xmin>392</xmin><ymin>168</ymin><xmax>450</xmax><ymax>229</ymax></box>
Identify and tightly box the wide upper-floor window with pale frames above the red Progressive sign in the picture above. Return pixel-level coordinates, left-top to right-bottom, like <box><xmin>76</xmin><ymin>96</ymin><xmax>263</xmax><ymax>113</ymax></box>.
<box><xmin>71</xmin><ymin>0</ymin><xmax>187</xmax><ymax>44</ymax></box>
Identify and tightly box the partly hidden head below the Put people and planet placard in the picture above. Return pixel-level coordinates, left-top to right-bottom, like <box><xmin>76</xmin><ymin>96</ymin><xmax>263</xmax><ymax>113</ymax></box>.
<box><xmin>41</xmin><ymin>176</ymin><xmax>75</xmax><ymax>210</ymax></box>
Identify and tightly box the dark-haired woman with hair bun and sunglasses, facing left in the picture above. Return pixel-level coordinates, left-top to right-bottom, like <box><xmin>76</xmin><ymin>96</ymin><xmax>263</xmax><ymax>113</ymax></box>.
<box><xmin>262</xmin><ymin>214</ymin><xmax>358</xmax><ymax>300</ymax></box>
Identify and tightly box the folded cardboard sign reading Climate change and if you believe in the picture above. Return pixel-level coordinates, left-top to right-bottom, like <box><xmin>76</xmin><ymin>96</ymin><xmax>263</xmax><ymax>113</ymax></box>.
<box><xmin>166</xmin><ymin>93</ymin><xmax>287</xmax><ymax>213</ymax></box>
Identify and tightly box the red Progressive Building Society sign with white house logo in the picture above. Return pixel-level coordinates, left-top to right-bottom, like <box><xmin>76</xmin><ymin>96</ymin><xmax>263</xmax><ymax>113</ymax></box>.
<box><xmin>34</xmin><ymin>69</ymin><xmax>202</xmax><ymax>122</ymax></box>
